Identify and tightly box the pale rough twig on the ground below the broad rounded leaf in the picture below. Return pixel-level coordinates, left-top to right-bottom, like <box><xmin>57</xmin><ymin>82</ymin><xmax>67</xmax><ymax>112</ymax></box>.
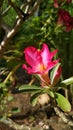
<box><xmin>54</xmin><ymin>107</ymin><xmax>73</xmax><ymax>126</ymax></box>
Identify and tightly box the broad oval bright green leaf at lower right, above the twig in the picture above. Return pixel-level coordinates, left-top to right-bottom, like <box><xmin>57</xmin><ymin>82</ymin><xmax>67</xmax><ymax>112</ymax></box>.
<box><xmin>55</xmin><ymin>93</ymin><xmax>71</xmax><ymax>112</ymax></box>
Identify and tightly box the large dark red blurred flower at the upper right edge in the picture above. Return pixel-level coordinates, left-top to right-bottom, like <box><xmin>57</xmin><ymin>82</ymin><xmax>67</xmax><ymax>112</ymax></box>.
<box><xmin>57</xmin><ymin>9</ymin><xmax>73</xmax><ymax>32</ymax></box>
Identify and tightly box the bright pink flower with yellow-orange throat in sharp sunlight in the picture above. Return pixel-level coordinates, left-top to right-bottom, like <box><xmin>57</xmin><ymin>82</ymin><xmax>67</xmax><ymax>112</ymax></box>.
<box><xmin>23</xmin><ymin>44</ymin><xmax>59</xmax><ymax>75</ymax></box>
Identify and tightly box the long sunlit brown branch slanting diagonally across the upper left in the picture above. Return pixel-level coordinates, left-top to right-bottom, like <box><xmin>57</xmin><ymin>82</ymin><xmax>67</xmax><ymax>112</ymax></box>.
<box><xmin>0</xmin><ymin>0</ymin><xmax>42</xmax><ymax>58</ymax></box>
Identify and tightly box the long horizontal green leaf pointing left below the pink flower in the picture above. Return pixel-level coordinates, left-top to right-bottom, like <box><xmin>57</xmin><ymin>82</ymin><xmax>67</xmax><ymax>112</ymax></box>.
<box><xmin>19</xmin><ymin>84</ymin><xmax>41</xmax><ymax>93</ymax></box>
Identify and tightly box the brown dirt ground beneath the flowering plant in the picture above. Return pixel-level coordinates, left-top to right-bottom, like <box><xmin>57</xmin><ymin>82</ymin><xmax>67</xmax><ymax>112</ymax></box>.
<box><xmin>0</xmin><ymin>94</ymin><xmax>73</xmax><ymax>130</ymax></box>
